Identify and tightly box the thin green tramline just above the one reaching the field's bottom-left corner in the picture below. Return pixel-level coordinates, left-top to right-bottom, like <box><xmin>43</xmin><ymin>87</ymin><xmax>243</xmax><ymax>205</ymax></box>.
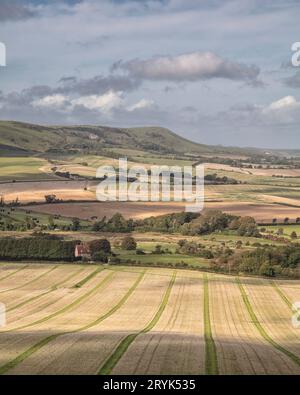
<box><xmin>1</xmin><ymin>269</ymin><xmax>111</xmax><ymax>333</ymax></box>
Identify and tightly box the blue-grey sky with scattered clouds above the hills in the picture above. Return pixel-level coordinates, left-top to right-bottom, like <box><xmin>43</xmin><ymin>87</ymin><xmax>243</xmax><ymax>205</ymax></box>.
<box><xmin>0</xmin><ymin>0</ymin><xmax>300</xmax><ymax>149</ymax></box>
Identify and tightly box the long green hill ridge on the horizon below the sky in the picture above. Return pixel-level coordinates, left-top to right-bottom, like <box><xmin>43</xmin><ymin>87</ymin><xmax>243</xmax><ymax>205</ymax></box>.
<box><xmin>0</xmin><ymin>121</ymin><xmax>263</xmax><ymax>156</ymax></box>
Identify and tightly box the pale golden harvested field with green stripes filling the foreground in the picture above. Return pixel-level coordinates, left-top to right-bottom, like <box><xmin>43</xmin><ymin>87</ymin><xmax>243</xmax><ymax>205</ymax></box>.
<box><xmin>0</xmin><ymin>263</ymin><xmax>300</xmax><ymax>375</ymax></box>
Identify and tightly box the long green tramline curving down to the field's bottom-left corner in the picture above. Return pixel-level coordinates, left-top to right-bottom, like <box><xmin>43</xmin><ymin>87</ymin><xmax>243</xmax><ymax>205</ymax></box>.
<box><xmin>0</xmin><ymin>271</ymin><xmax>145</xmax><ymax>375</ymax></box>
